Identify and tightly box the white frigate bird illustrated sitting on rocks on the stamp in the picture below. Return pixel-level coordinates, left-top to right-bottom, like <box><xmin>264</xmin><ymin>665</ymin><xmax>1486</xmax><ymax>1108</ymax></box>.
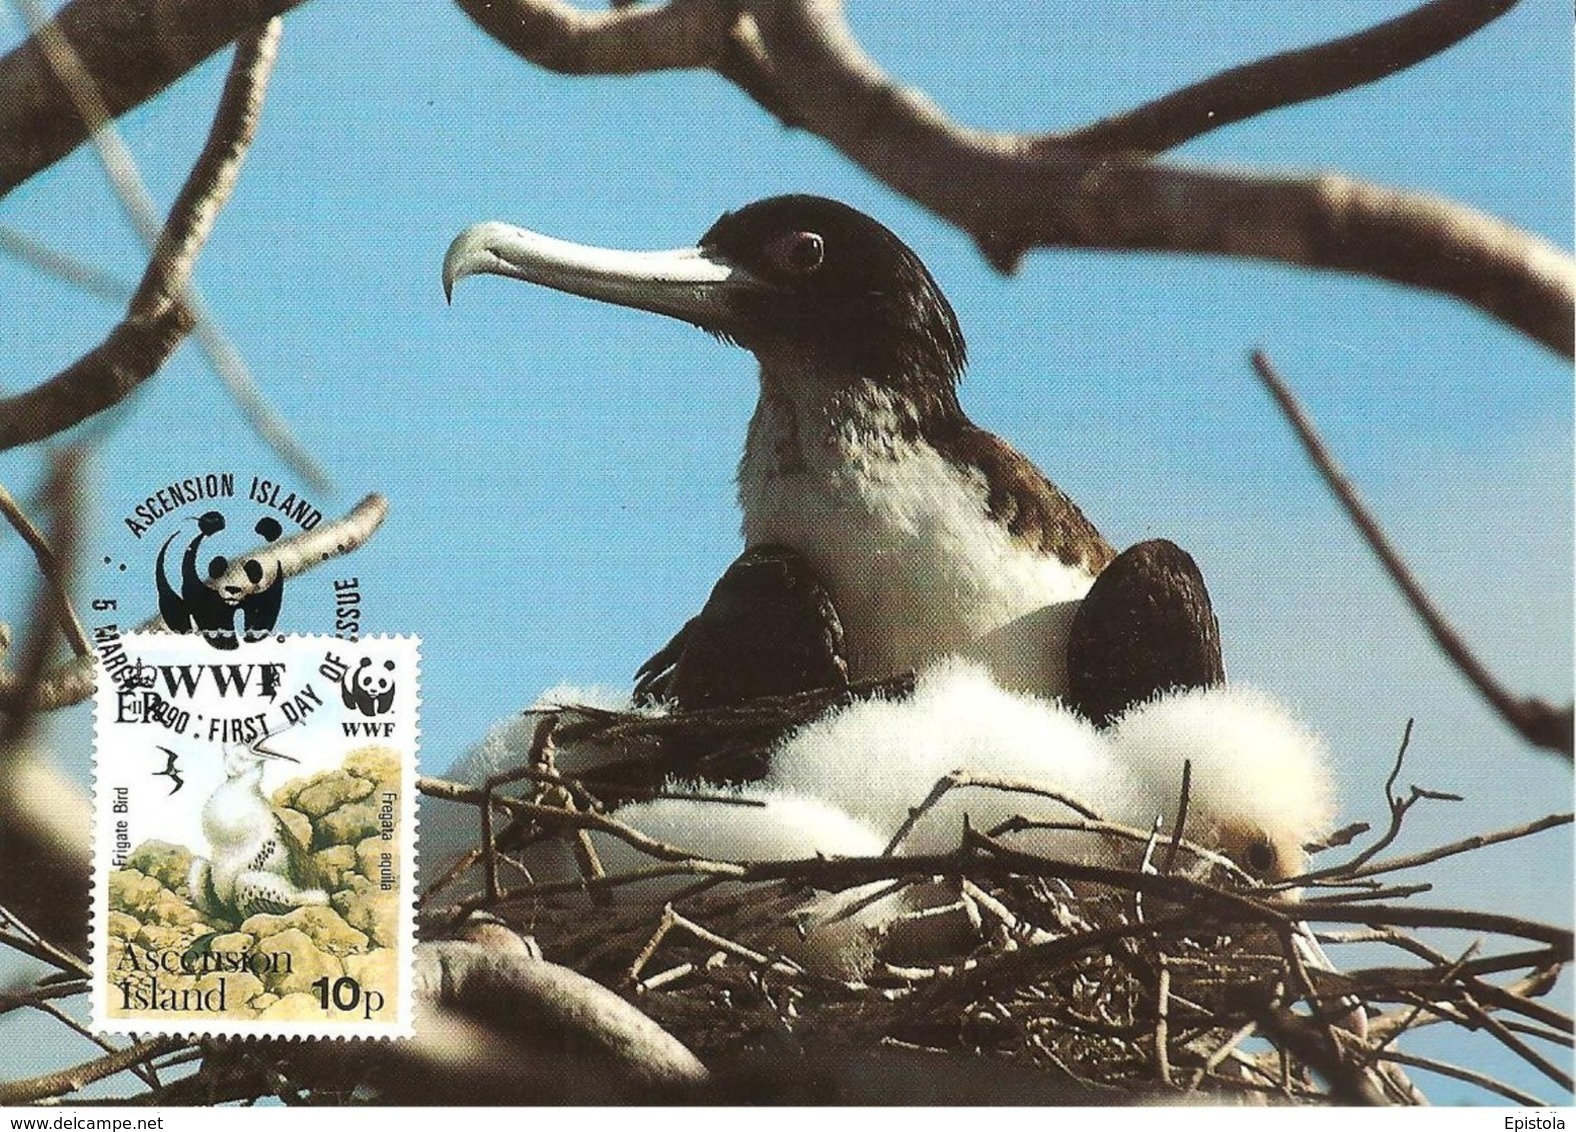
<box><xmin>188</xmin><ymin>738</ymin><xmax>328</xmax><ymax>919</ymax></box>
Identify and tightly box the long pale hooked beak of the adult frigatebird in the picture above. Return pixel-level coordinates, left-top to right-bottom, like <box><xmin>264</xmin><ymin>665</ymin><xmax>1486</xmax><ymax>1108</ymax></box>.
<box><xmin>443</xmin><ymin>221</ymin><xmax>769</xmax><ymax>333</ymax></box>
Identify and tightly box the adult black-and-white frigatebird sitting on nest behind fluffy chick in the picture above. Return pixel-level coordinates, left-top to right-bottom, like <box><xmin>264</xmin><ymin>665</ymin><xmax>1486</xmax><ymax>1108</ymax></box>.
<box><xmin>443</xmin><ymin>195</ymin><xmax>1223</xmax><ymax>724</ymax></box>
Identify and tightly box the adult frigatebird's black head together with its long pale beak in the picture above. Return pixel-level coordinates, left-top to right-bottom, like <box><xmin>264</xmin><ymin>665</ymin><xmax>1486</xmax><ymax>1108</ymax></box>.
<box><xmin>443</xmin><ymin>195</ymin><xmax>965</xmax><ymax>404</ymax></box>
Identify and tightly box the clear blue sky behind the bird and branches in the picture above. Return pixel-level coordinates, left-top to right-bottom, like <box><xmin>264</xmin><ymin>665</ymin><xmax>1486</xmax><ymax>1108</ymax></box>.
<box><xmin>0</xmin><ymin>0</ymin><xmax>1573</xmax><ymax>1097</ymax></box>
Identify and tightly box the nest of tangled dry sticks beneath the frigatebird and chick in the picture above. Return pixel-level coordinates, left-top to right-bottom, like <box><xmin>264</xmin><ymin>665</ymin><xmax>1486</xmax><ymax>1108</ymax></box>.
<box><xmin>409</xmin><ymin>681</ymin><xmax>1571</xmax><ymax>1104</ymax></box>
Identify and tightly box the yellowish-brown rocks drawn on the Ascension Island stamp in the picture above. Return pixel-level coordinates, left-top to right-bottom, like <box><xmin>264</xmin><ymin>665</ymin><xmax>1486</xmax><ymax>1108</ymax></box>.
<box><xmin>107</xmin><ymin>747</ymin><xmax>407</xmax><ymax>1022</ymax></box>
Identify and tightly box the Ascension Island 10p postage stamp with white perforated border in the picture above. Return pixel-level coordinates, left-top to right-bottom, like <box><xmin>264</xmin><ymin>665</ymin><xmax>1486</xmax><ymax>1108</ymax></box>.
<box><xmin>93</xmin><ymin>634</ymin><xmax>421</xmax><ymax>1037</ymax></box>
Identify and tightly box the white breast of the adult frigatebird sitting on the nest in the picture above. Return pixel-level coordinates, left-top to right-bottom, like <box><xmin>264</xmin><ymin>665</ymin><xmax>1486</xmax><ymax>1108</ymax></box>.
<box><xmin>739</xmin><ymin>376</ymin><xmax>1094</xmax><ymax>695</ymax></box>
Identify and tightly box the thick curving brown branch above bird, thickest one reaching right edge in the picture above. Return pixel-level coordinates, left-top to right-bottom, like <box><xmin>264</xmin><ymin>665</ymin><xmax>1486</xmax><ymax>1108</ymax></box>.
<box><xmin>752</xmin><ymin>0</ymin><xmax>1576</xmax><ymax>356</ymax></box>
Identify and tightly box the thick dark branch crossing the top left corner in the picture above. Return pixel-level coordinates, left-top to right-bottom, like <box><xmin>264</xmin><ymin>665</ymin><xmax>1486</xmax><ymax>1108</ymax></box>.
<box><xmin>0</xmin><ymin>0</ymin><xmax>299</xmax><ymax>197</ymax></box>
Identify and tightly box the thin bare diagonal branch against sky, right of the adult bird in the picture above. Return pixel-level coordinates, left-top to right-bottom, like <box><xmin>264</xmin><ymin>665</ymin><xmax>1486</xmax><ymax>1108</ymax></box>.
<box><xmin>1253</xmin><ymin>350</ymin><xmax>1576</xmax><ymax>758</ymax></box>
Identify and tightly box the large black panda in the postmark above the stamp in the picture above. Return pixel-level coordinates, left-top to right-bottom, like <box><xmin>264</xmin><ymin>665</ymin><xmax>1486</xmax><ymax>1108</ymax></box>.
<box><xmin>153</xmin><ymin>511</ymin><xmax>285</xmax><ymax>648</ymax></box>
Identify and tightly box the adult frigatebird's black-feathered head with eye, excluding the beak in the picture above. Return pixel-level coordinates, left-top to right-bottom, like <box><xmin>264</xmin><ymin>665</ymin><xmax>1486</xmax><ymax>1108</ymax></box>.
<box><xmin>700</xmin><ymin>195</ymin><xmax>966</xmax><ymax>397</ymax></box>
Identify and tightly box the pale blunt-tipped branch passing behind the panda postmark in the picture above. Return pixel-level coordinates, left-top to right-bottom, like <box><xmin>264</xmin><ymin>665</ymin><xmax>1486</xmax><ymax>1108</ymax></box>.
<box><xmin>0</xmin><ymin>493</ymin><xmax>389</xmax><ymax>711</ymax></box>
